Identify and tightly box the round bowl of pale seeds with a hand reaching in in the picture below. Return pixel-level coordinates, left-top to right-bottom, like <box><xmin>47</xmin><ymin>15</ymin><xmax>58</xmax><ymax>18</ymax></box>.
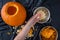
<box><xmin>33</xmin><ymin>7</ymin><xmax>50</xmax><ymax>23</ymax></box>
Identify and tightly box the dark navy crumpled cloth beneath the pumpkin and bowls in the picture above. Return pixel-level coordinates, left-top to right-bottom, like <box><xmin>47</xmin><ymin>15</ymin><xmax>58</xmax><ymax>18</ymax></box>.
<box><xmin>0</xmin><ymin>0</ymin><xmax>60</xmax><ymax>40</ymax></box>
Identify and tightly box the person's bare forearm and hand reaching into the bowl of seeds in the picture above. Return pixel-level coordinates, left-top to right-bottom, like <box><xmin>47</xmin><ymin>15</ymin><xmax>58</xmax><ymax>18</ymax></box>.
<box><xmin>14</xmin><ymin>13</ymin><xmax>40</xmax><ymax>40</ymax></box>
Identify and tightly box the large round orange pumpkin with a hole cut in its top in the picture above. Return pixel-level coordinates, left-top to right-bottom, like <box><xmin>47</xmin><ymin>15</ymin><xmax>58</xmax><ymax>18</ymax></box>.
<box><xmin>1</xmin><ymin>2</ymin><xmax>26</xmax><ymax>26</ymax></box>
